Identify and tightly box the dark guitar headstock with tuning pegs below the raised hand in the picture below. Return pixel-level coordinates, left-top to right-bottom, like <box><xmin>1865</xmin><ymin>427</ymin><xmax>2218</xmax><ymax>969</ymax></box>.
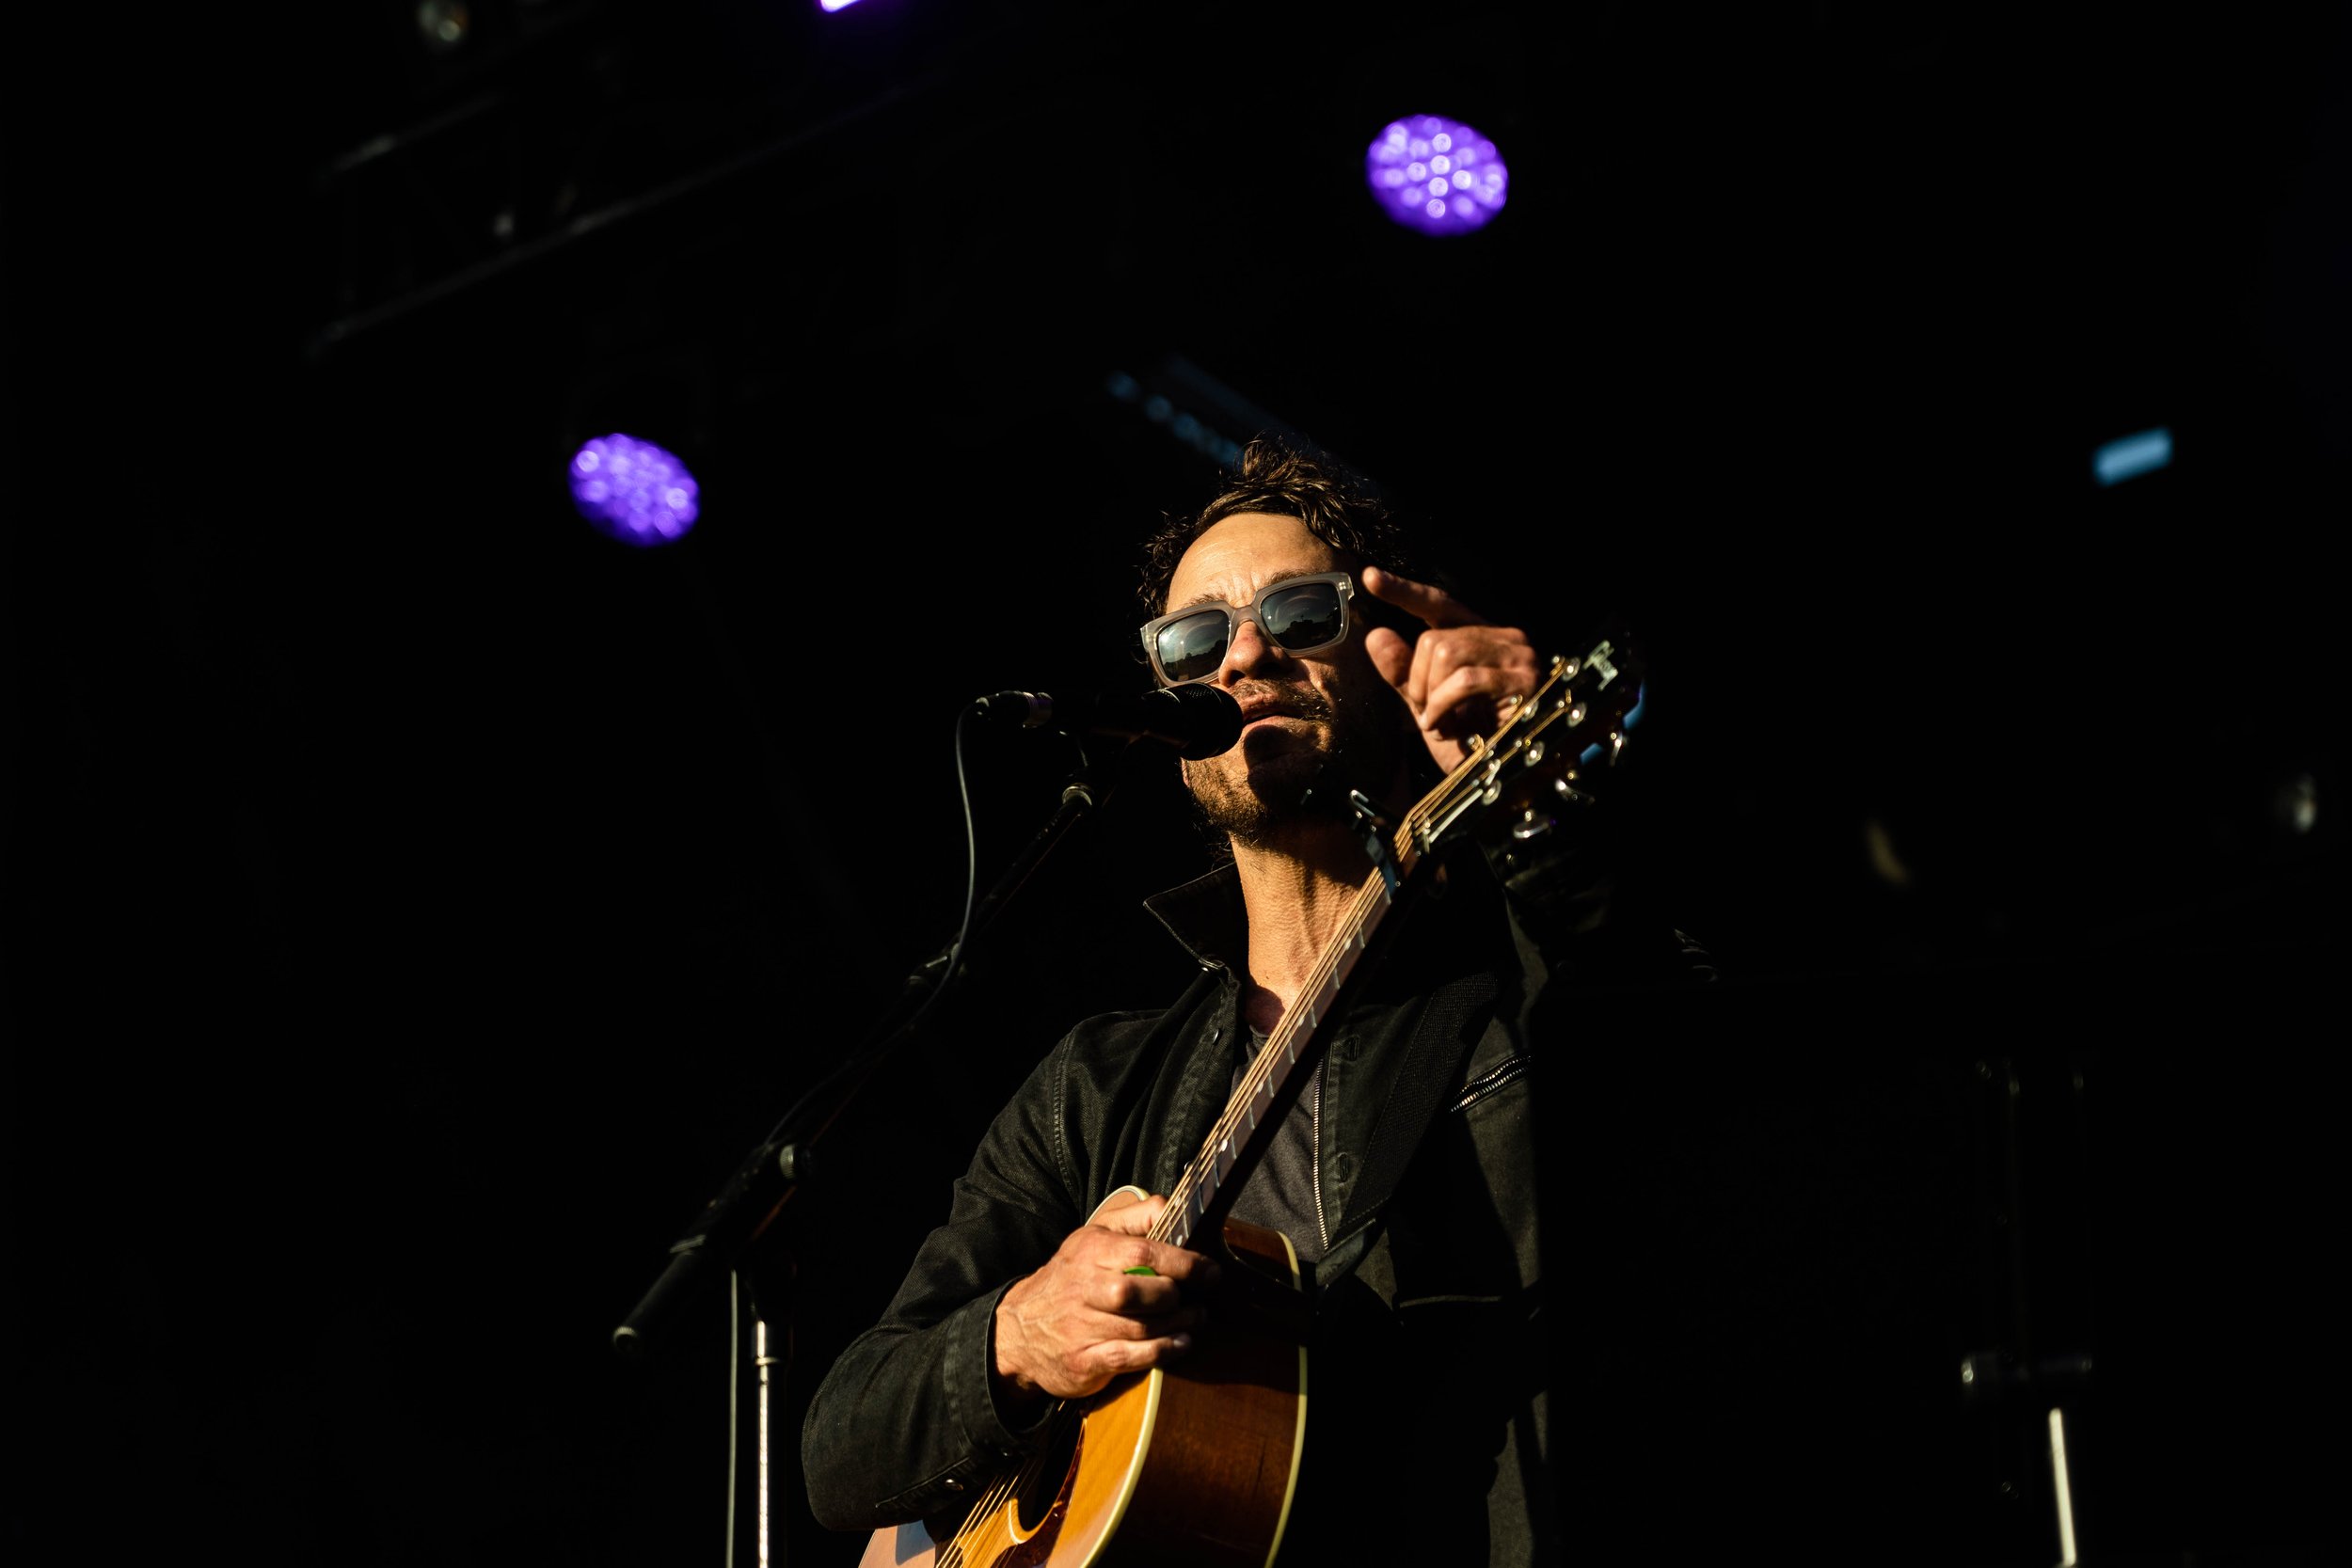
<box><xmin>1406</xmin><ymin>627</ymin><xmax>1642</xmax><ymax>848</ymax></box>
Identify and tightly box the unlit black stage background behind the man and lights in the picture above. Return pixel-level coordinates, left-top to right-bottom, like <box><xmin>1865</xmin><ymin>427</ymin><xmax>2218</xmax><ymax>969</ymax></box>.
<box><xmin>5</xmin><ymin>0</ymin><xmax>2352</xmax><ymax>1563</ymax></box>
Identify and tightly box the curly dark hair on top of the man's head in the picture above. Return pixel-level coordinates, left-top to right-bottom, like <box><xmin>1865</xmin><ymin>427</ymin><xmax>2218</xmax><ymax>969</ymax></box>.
<box><xmin>1136</xmin><ymin>435</ymin><xmax>1452</xmax><ymax>635</ymax></box>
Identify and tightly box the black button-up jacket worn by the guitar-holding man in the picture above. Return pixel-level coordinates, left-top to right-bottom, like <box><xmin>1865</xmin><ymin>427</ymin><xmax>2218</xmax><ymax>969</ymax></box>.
<box><xmin>803</xmin><ymin>827</ymin><xmax>1712</xmax><ymax>1568</ymax></box>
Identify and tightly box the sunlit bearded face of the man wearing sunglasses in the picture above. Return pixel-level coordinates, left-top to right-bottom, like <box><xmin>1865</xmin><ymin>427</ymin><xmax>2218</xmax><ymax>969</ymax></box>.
<box><xmin>1165</xmin><ymin>513</ymin><xmax>1409</xmax><ymax>844</ymax></box>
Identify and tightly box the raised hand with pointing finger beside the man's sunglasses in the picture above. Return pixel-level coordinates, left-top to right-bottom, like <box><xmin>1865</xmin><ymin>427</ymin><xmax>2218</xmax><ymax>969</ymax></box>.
<box><xmin>1364</xmin><ymin>566</ymin><xmax>1543</xmax><ymax>773</ymax></box>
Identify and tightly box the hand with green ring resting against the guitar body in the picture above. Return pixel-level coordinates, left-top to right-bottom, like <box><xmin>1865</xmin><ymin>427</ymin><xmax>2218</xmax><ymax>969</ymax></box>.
<box><xmin>995</xmin><ymin>1195</ymin><xmax>1216</xmax><ymax>1406</ymax></box>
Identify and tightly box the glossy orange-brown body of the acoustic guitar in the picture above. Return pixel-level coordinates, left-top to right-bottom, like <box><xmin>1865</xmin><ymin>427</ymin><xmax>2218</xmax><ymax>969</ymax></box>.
<box><xmin>859</xmin><ymin>1187</ymin><xmax>1308</xmax><ymax>1568</ymax></box>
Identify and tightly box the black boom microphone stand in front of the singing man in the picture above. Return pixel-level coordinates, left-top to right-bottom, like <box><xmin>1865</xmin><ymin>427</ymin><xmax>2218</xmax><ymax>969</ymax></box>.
<box><xmin>612</xmin><ymin>736</ymin><xmax>1108</xmax><ymax>1568</ymax></box>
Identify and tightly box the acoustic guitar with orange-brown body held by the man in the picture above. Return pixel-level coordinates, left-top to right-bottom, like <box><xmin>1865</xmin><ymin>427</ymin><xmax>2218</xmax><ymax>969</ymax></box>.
<box><xmin>859</xmin><ymin>637</ymin><xmax>1640</xmax><ymax>1568</ymax></box>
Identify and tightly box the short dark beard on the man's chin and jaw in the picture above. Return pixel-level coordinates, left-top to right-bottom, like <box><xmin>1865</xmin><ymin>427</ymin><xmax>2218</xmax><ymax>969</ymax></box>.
<box><xmin>1184</xmin><ymin>682</ymin><xmax>1419</xmax><ymax>848</ymax></box>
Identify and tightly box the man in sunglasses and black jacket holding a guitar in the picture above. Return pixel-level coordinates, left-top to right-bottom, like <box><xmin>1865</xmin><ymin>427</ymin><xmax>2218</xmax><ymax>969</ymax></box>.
<box><xmin>804</xmin><ymin>439</ymin><xmax>1708</xmax><ymax>1568</ymax></box>
